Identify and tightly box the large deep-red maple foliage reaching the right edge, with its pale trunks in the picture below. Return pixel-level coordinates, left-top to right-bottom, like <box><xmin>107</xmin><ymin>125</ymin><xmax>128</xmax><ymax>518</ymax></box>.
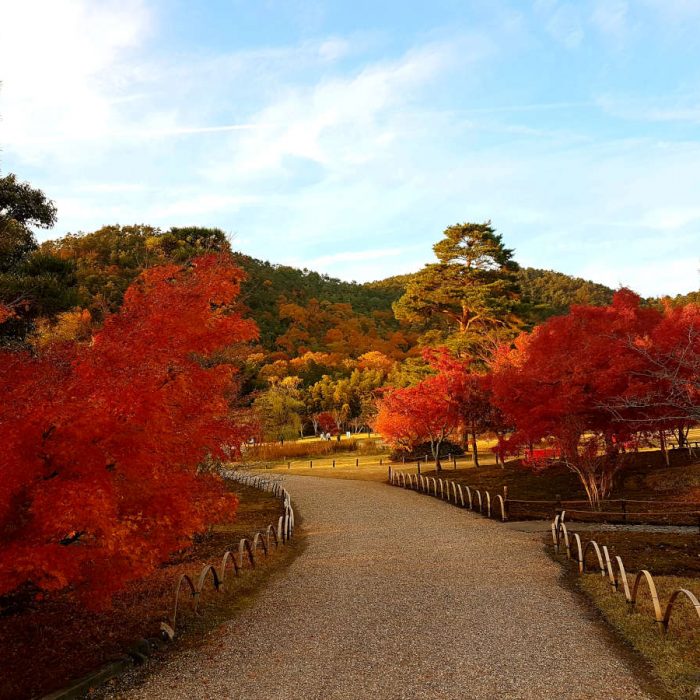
<box><xmin>493</xmin><ymin>289</ymin><xmax>700</xmax><ymax>505</ymax></box>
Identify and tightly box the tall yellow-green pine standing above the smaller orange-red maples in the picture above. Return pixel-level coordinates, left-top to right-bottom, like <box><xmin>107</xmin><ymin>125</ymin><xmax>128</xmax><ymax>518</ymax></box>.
<box><xmin>394</xmin><ymin>222</ymin><xmax>520</xmax><ymax>348</ymax></box>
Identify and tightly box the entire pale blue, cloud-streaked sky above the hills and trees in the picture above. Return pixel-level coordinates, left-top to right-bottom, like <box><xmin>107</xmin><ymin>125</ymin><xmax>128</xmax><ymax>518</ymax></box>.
<box><xmin>0</xmin><ymin>0</ymin><xmax>700</xmax><ymax>295</ymax></box>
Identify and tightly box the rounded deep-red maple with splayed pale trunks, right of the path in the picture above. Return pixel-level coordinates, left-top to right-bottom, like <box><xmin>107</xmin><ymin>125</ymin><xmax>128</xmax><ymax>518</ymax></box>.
<box><xmin>493</xmin><ymin>289</ymin><xmax>664</xmax><ymax>506</ymax></box>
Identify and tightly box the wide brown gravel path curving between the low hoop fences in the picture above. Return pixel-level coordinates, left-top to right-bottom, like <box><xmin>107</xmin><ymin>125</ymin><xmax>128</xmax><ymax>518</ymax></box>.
<box><xmin>119</xmin><ymin>477</ymin><xmax>651</xmax><ymax>700</ymax></box>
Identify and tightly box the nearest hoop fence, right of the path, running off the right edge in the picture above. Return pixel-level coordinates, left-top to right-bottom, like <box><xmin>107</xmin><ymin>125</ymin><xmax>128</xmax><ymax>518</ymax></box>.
<box><xmin>551</xmin><ymin>511</ymin><xmax>700</xmax><ymax>637</ymax></box>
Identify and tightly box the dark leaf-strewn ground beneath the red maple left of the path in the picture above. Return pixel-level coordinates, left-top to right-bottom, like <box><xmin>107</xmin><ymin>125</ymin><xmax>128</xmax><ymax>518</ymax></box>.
<box><xmin>0</xmin><ymin>483</ymin><xmax>295</xmax><ymax>700</ymax></box>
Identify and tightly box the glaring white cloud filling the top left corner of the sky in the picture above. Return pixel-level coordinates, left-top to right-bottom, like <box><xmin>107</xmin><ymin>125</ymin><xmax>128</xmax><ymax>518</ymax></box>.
<box><xmin>0</xmin><ymin>0</ymin><xmax>150</xmax><ymax>162</ymax></box>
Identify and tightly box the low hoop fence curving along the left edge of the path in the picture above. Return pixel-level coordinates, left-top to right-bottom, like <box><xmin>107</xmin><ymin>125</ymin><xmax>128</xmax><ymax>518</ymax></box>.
<box><xmin>160</xmin><ymin>470</ymin><xmax>294</xmax><ymax>641</ymax></box>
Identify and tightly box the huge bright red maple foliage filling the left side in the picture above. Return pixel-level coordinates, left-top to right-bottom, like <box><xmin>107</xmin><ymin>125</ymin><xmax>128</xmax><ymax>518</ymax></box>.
<box><xmin>0</xmin><ymin>255</ymin><xmax>257</xmax><ymax>605</ymax></box>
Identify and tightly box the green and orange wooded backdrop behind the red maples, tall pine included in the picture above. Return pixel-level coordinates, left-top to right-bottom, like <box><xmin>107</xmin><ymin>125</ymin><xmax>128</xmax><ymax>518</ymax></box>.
<box><xmin>0</xmin><ymin>176</ymin><xmax>688</xmax><ymax>452</ymax></box>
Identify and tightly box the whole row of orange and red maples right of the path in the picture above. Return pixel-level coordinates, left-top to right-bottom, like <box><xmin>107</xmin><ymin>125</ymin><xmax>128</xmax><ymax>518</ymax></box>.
<box><xmin>375</xmin><ymin>289</ymin><xmax>700</xmax><ymax>506</ymax></box>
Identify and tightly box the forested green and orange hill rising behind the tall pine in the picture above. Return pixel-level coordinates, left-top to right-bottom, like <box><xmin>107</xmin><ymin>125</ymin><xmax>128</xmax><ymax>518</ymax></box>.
<box><xmin>34</xmin><ymin>226</ymin><xmax>624</xmax><ymax>356</ymax></box>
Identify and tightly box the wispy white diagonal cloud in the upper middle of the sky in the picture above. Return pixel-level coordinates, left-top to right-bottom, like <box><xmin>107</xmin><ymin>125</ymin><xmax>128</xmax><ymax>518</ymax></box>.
<box><xmin>200</xmin><ymin>40</ymin><xmax>468</xmax><ymax>181</ymax></box>
